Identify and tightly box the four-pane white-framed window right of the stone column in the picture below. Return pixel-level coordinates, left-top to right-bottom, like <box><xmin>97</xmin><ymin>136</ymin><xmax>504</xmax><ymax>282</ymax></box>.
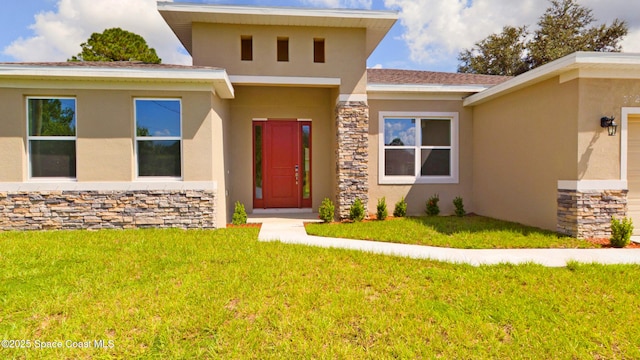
<box><xmin>379</xmin><ymin>113</ymin><xmax>458</xmax><ymax>184</ymax></box>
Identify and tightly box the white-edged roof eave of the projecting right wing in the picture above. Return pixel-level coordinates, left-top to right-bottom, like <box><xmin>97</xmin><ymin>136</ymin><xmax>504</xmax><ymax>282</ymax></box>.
<box><xmin>464</xmin><ymin>52</ymin><xmax>640</xmax><ymax>106</ymax></box>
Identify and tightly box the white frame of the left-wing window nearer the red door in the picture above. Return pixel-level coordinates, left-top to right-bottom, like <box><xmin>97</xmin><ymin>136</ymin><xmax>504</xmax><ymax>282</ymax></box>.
<box><xmin>133</xmin><ymin>97</ymin><xmax>184</xmax><ymax>181</ymax></box>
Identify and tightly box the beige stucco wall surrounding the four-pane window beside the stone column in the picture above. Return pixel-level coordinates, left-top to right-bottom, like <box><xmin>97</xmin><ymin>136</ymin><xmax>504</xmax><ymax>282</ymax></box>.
<box><xmin>368</xmin><ymin>100</ymin><xmax>474</xmax><ymax>215</ymax></box>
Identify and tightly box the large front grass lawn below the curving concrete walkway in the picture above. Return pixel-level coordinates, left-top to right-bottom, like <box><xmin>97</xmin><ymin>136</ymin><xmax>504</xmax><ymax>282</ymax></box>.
<box><xmin>0</xmin><ymin>228</ymin><xmax>640</xmax><ymax>359</ymax></box>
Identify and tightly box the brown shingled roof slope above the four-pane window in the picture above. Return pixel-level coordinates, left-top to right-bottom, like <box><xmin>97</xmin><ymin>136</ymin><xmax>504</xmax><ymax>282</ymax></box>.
<box><xmin>367</xmin><ymin>69</ymin><xmax>511</xmax><ymax>86</ymax></box>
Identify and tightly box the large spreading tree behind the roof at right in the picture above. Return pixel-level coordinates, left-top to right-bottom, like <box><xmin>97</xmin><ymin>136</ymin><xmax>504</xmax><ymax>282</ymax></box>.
<box><xmin>458</xmin><ymin>0</ymin><xmax>628</xmax><ymax>76</ymax></box>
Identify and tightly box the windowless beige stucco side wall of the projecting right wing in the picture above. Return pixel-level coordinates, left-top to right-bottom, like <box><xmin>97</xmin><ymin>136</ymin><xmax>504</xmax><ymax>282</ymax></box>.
<box><xmin>473</xmin><ymin>77</ymin><xmax>580</xmax><ymax>230</ymax></box>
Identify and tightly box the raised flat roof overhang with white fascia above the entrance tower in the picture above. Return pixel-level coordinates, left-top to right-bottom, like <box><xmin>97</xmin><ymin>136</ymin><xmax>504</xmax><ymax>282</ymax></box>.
<box><xmin>158</xmin><ymin>2</ymin><xmax>398</xmax><ymax>56</ymax></box>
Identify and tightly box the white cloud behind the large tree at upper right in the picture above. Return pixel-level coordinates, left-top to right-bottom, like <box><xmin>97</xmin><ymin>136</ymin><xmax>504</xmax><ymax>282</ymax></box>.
<box><xmin>384</xmin><ymin>0</ymin><xmax>640</xmax><ymax>69</ymax></box>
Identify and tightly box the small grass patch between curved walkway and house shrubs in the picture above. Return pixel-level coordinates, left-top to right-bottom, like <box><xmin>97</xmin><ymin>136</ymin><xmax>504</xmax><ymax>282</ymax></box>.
<box><xmin>306</xmin><ymin>216</ymin><xmax>600</xmax><ymax>249</ymax></box>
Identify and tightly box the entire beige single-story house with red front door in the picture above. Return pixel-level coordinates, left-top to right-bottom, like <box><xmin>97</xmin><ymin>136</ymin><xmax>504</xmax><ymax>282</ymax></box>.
<box><xmin>0</xmin><ymin>2</ymin><xmax>640</xmax><ymax>237</ymax></box>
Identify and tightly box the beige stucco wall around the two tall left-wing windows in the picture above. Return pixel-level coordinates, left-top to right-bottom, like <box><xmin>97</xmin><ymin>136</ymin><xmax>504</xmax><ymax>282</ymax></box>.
<box><xmin>0</xmin><ymin>82</ymin><xmax>228</xmax><ymax>226</ymax></box>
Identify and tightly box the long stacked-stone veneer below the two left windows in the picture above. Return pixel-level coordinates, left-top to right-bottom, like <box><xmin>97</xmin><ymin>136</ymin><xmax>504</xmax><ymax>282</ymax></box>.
<box><xmin>0</xmin><ymin>190</ymin><xmax>216</xmax><ymax>230</ymax></box>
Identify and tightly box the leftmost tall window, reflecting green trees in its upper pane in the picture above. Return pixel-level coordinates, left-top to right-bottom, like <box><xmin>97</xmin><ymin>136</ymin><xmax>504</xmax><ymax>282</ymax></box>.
<box><xmin>27</xmin><ymin>97</ymin><xmax>76</xmax><ymax>179</ymax></box>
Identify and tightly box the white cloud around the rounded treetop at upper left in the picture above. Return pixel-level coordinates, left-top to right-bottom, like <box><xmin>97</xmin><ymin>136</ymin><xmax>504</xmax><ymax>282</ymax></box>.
<box><xmin>3</xmin><ymin>0</ymin><xmax>191</xmax><ymax>64</ymax></box>
